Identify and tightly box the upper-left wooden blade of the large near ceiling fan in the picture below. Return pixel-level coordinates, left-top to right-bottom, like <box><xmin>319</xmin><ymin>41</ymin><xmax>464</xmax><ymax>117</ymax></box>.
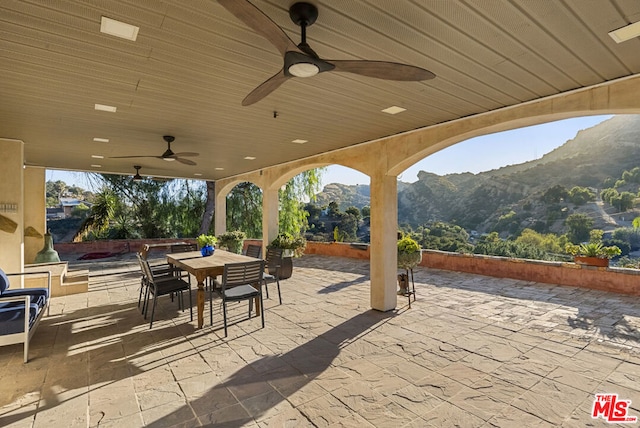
<box><xmin>218</xmin><ymin>0</ymin><xmax>299</xmax><ymax>56</ymax></box>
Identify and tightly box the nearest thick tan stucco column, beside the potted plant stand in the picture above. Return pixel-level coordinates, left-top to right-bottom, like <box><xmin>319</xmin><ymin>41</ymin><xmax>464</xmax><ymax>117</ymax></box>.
<box><xmin>370</xmin><ymin>173</ymin><xmax>398</xmax><ymax>311</ymax></box>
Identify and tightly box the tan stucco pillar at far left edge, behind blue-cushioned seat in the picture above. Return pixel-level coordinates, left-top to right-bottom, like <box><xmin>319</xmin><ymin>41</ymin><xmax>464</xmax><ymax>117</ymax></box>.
<box><xmin>0</xmin><ymin>139</ymin><xmax>24</xmax><ymax>272</ymax></box>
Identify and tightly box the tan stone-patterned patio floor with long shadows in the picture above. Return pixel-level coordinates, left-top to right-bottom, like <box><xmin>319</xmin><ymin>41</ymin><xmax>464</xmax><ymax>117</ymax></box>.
<box><xmin>0</xmin><ymin>255</ymin><xmax>640</xmax><ymax>428</ymax></box>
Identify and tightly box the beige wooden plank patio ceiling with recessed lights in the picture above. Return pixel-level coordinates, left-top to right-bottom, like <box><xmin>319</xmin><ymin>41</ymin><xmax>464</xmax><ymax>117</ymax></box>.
<box><xmin>0</xmin><ymin>0</ymin><xmax>640</xmax><ymax>180</ymax></box>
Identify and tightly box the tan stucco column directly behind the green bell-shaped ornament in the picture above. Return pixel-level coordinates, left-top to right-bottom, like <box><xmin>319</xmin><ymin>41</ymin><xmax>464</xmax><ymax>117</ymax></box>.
<box><xmin>24</xmin><ymin>167</ymin><xmax>47</xmax><ymax>264</ymax></box>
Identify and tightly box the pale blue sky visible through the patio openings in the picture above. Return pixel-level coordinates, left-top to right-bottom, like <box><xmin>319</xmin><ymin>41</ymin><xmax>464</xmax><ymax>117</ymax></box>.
<box><xmin>46</xmin><ymin>115</ymin><xmax>611</xmax><ymax>189</ymax></box>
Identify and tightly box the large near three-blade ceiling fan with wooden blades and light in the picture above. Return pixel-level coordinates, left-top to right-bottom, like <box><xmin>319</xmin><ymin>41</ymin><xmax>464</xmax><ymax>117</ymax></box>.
<box><xmin>218</xmin><ymin>0</ymin><xmax>436</xmax><ymax>106</ymax></box>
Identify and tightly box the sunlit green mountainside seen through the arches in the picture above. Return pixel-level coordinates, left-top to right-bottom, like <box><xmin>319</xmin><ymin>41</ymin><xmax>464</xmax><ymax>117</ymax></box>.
<box><xmin>316</xmin><ymin>115</ymin><xmax>640</xmax><ymax>232</ymax></box>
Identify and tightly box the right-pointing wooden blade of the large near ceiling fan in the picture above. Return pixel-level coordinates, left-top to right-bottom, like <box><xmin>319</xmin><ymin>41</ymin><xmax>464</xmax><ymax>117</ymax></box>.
<box><xmin>326</xmin><ymin>60</ymin><xmax>436</xmax><ymax>82</ymax></box>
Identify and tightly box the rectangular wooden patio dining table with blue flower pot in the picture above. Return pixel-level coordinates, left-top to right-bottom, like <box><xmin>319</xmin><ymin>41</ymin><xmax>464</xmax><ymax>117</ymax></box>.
<box><xmin>167</xmin><ymin>249</ymin><xmax>260</xmax><ymax>328</ymax></box>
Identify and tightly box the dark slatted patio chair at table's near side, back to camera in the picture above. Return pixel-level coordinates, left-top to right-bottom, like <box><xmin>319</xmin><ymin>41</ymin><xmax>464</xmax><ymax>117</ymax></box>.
<box><xmin>209</xmin><ymin>260</ymin><xmax>264</xmax><ymax>337</ymax></box>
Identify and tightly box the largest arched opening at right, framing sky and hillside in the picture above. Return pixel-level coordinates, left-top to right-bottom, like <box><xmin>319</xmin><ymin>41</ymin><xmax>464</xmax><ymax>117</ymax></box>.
<box><xmin>398</xmin><ymin>115</ymin><xmax>640</xmax><ymax>267</ymax></box>
